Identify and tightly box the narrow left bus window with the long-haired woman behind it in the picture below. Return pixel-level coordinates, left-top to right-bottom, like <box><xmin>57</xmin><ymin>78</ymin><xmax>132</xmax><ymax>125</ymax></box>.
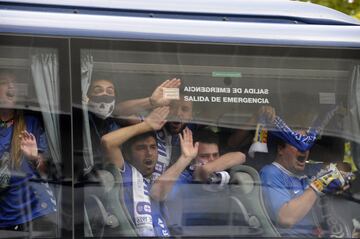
<box><xmin>0</xmin><ymin>41</ymin><xmax>69</xmax><ymax>238</ymax></box>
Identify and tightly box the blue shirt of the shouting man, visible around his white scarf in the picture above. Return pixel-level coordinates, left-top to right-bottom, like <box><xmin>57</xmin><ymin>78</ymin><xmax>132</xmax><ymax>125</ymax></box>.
<box><xmin>122</xmin><ymin>161</ymin><xmax>170</xmax><ymax>237</ymax></box>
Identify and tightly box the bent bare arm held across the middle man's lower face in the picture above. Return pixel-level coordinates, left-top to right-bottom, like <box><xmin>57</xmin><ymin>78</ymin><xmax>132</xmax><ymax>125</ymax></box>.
<box><xmin>194</xmin><ymin>152</ymin><xmax>246</xmax><ymax>182</ymax></box>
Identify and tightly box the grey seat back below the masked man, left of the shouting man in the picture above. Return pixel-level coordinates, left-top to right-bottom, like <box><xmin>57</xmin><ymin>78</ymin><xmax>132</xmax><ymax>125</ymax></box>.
<box><xmin>84</xmin><ymin>165</ymin><xmax>137</xmax><ymax>237</ymax></box>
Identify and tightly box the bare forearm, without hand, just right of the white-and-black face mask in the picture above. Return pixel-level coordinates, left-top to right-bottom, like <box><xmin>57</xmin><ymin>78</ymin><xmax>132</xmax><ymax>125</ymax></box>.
<box><xmin>114</xmin><ymin>97</ymin><xmax>153</xmax><ymax>116</ymax></box>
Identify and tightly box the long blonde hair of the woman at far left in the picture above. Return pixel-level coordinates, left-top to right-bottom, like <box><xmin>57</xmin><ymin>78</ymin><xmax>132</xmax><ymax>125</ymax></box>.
<box><xmin>10</xmin><ymin>110</ymin><xmax>26</xmax><ymax>169</ymax></box>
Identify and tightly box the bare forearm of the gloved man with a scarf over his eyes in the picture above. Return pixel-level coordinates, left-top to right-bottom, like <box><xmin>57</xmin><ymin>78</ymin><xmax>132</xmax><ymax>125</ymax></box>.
<box><xmin>278</xmin><ymin>187</ymin><xmax>317</xmax><ymax>228</ymax></box>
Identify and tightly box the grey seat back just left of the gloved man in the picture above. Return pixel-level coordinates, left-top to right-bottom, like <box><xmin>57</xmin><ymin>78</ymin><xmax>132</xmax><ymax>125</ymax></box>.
<box><xmin>230</xmin><ymin>165</ymin><xmax>280</xmax><ymax>237</ymax></box>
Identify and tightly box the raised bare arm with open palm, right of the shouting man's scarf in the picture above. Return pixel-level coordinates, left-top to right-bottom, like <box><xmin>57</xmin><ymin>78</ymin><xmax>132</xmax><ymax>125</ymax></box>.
<box><xmin>151</xmin><ymin>128</ymin><xmax>199</xmax><ymax>201</ymax></box>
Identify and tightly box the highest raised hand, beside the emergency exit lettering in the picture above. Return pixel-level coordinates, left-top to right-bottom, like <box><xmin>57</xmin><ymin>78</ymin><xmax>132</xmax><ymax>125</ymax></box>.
<box><xmin>149</xmin><ymin>78</ymin><xmax>181</xmax><ymax>107</ymax></box>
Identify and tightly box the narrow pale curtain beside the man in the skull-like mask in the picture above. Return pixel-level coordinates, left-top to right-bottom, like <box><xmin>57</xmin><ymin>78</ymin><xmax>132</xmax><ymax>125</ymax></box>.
<box><xmin>81</xmin><ymin>50</ymin><xmax>94</xmax><ymax>174</ymax></box>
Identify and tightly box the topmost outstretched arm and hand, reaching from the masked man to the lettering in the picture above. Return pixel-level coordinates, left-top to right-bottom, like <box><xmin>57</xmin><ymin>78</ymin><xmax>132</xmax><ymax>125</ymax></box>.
<box><xmin>114</xmin><ymin>78</ymin><xmax>181</xmax><ymax>116</ymax></box>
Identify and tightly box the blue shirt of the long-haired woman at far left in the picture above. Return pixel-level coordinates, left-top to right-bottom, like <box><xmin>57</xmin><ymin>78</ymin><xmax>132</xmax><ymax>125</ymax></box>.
<box><xmin>0</xmin><ymin>116</ymin><xmax>56</xmax><ymax>228</ymax></box>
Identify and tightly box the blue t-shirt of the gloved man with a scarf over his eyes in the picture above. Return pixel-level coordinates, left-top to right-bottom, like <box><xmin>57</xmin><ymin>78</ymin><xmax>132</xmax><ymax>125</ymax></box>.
<box><xmin>260</xmin><ymin>162</ymin><xmax>316</xmax><ymax>237</ymax></box>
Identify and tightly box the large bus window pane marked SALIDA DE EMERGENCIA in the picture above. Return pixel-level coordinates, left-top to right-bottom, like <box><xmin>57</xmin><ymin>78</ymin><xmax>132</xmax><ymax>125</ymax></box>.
<box><xmin>79</xmin><ymin>41</ymin><xmax>360</xmax><ymax>237</ymax></box>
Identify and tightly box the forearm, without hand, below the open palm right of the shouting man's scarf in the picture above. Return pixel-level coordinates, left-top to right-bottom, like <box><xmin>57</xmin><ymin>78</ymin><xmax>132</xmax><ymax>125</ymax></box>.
<box><xmin>151</xmin><ymin>156</ymin><xmax>191</xmax><ymax>201</ymax></box>
